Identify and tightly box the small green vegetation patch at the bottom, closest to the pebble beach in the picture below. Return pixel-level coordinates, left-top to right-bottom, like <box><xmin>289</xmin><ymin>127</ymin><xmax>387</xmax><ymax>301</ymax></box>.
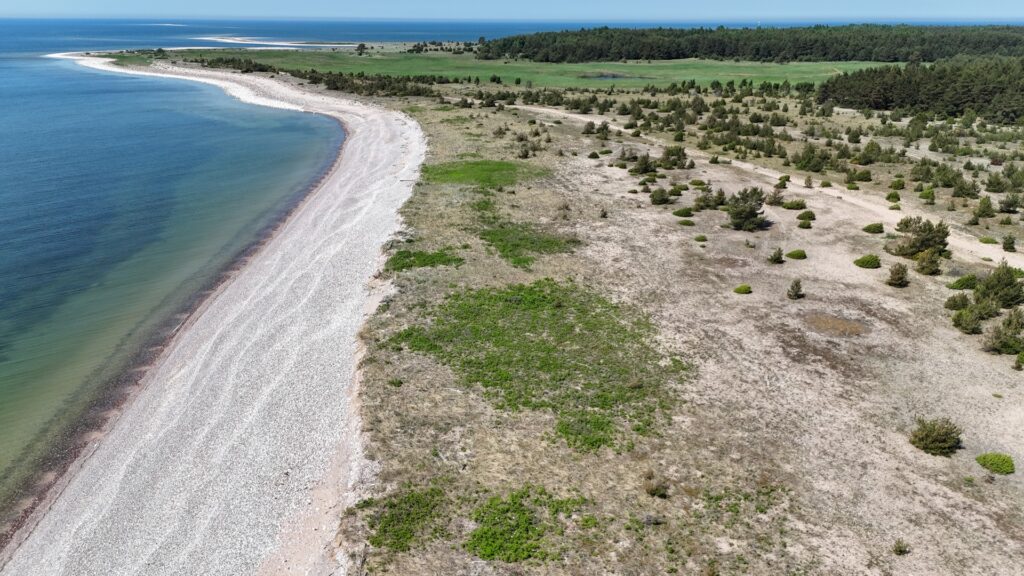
<box><xmin>366</xmin><ymin>486</ymin><xmax>446</xmax><ymax>552</ymax></box>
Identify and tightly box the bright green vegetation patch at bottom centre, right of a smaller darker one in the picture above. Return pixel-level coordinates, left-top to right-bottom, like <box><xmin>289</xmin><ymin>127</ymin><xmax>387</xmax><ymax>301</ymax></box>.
<box><xmin>465</xmin><ymin>486</ymin><xmax>584</xmax><ymax>562</ymax></box>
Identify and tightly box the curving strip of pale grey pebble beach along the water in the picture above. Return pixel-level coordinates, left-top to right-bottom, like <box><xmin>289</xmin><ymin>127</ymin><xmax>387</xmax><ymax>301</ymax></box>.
<box><xmin>0</xmin><ymin>54</ymin><xmax>426</xmax><ymax>576</ymax></box>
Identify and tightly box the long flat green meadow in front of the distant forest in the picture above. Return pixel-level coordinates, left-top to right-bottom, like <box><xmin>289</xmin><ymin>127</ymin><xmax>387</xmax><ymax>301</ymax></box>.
<box><xmin>167</xmin><ymin>50</ymin><xmax>877</xmax><ymax>88</ymax></box>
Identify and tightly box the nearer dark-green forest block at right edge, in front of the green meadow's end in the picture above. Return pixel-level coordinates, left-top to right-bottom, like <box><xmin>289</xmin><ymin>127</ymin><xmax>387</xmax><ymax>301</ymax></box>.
<box><xmin>818</xmin><ymin>56</ymin><xmax>1024</xmax><ymax>123</ymax></box>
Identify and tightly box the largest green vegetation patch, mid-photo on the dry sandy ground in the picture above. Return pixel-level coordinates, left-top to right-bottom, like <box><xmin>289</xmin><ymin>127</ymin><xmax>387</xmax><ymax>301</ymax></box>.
<box><xmin>392</xmin><ymin>279</ymin><xmax>687</xmax><ymax>452</ymax></box>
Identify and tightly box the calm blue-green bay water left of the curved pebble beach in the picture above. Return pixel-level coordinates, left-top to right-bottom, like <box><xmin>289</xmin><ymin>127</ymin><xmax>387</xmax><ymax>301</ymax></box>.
<box><xmin>0</xmin><ymin>23</ymin><xmax>343</xmax><ymax>510</ymax></box>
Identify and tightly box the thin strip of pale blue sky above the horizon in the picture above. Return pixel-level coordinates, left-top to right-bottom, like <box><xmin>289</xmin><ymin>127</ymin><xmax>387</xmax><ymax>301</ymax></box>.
<box><xmin>6</xmin><ymin>0</ymin><xmax>1024</xmax><ymax>23</ymax></box>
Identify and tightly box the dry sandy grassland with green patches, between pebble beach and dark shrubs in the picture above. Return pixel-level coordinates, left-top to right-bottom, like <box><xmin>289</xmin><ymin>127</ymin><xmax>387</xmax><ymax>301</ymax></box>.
<box><xmin>315</xmin><ymin>86</ymin><xmax>1024</xmax><ymax>575</ymax></box>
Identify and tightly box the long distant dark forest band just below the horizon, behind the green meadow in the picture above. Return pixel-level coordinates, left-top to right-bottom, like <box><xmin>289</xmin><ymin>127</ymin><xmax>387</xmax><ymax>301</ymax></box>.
<box><xmin>477</xmin><ymin>25</ymin><xmax>1024</xmax><ymax>63</ymax></box>
